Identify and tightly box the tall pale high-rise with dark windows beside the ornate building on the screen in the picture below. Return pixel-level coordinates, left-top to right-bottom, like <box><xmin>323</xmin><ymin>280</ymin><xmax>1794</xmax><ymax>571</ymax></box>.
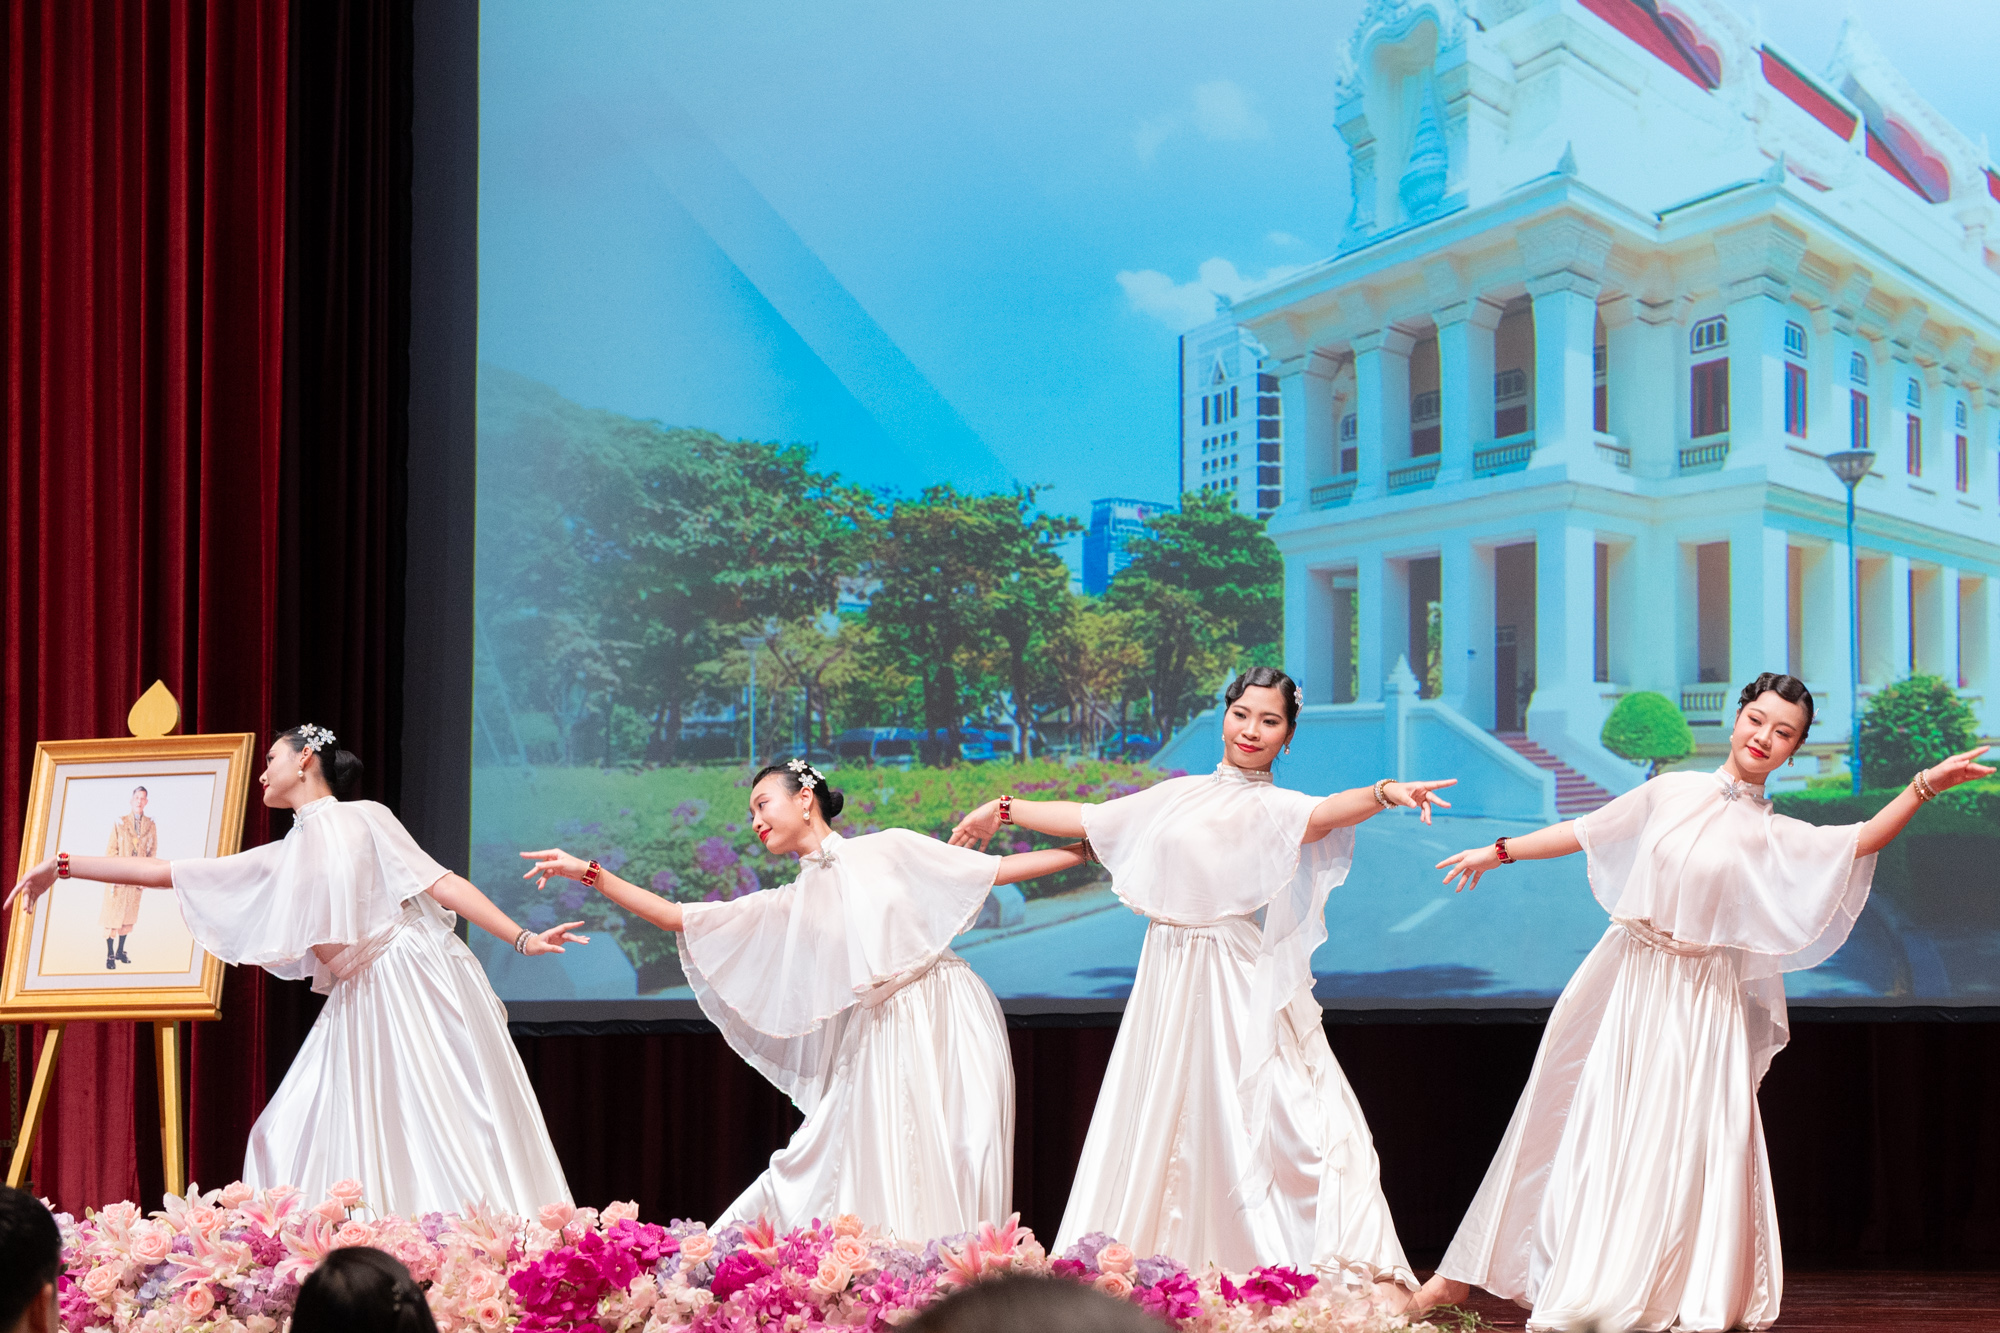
<box><xmin>1180</xmin><ymin>324</ymin><xmax>1284</xmax><ymax>518</ymax></box>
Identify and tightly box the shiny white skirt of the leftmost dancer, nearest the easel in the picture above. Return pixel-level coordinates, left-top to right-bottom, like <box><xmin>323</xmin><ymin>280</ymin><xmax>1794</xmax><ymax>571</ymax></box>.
<box><xmin>244</xmin><ymin>897</ymin><xmax>570</xmax><ymax>1217</ymax></box>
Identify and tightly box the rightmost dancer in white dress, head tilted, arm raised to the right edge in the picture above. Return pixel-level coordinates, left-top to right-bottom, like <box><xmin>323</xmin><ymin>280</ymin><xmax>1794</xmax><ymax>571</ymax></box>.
<box><xmin>1418</xmin><ymin>673</ymin><xmax>1992</xmax><ymax>1331</ymax></box>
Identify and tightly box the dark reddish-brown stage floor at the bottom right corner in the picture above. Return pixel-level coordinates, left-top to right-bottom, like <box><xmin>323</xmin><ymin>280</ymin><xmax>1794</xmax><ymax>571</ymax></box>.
<box><xmin>1468</xmin><ymin>1273</ymin><xmax>2000</xmax><ymax>1333</ymax></box>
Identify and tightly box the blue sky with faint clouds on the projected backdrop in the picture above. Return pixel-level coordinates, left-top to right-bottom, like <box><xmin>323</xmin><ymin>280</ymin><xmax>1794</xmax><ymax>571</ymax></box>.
<box><xmin>480</xmin><ymin>0</ymin><xmax>2000</xmax><ymax>536</ymax></box>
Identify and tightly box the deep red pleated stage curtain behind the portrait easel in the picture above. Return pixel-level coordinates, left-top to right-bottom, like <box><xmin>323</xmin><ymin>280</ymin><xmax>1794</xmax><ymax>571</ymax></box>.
<box><xmin>0</xmin><ymin>0</ymin><xmax>288</xmax><ymax>1209</ymax></box>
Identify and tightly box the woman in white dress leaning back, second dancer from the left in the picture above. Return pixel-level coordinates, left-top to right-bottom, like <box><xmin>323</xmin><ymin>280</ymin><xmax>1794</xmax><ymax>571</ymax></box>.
<box><xmin>522</xmin><ymin>759</ymin><xmax>1084</xmax><ymax>1241</ymax></box>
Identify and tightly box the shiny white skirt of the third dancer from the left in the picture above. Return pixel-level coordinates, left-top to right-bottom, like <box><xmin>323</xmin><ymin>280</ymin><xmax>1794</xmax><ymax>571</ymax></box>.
<box><xmin>1050</xmin><ymin>917</ymin><xmax>1416</xmax><ymax>1287</ymax></box>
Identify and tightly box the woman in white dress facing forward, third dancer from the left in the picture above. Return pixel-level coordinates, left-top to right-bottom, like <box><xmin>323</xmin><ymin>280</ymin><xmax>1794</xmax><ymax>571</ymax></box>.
<box><xmin>952</xmin><ymin>667</ymin><xmax>1450</xmax><ymax>1307</ymax></box>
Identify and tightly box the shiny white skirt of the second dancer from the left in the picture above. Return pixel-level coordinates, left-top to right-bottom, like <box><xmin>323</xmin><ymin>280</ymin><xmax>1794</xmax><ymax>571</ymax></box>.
<box><xmin>716</xmin><ymin>951</ymin><xmax>1014</xmax><ymax>1241</ymax></box>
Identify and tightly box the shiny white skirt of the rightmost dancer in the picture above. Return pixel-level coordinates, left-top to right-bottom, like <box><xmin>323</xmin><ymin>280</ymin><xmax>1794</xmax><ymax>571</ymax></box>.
<box><xmin>1438</xmin><ymin>925</ymin><xmax>1784</xmax><ymax>1333</ymax></box>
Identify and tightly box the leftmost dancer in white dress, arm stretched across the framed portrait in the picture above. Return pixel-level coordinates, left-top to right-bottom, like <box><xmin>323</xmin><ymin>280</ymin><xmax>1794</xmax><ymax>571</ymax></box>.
<box><xmin>8</xmin><ymin>727</ymin><xmax>588</xmax><ymax>1217</ymax></box>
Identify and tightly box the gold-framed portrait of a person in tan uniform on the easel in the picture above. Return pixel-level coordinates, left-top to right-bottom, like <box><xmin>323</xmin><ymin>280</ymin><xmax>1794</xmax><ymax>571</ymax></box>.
<box><xmin>0</xmin><ymin>733</ymin><xmax>256</xmax><ymax>1023</ymax></box>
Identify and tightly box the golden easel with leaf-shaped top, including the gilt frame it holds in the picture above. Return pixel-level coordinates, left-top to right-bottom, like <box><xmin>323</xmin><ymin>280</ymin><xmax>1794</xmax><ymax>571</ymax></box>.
<box><xmin>0</xmin><ymin>681</ymin><xmax>256</xmax><ymax>1195</ymax></box>
